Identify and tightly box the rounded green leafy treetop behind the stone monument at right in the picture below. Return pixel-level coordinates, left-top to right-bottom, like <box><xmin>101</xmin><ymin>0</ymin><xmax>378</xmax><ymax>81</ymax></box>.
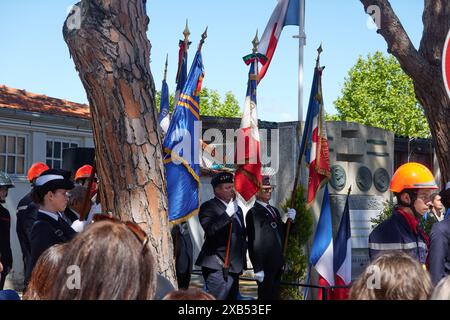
<box><xmin>327</xmin><ymin>51</ymin><xmax>430</xmax><ymax>138</ymax></box>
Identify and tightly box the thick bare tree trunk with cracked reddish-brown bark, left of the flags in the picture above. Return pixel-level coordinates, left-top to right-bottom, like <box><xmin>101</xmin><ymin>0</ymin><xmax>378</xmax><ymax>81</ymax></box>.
<box><xmin>63</xmin><ymin>0</ymin><xmax>175</xmax><ymax>283</ymax></box>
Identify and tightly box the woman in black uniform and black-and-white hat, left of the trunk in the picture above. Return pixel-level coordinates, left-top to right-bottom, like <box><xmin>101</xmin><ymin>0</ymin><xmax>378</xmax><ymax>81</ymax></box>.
<box><xmin>25</xmin><ymin>169</ymin><xmax>76</xmax><ymax>283</ymax></box>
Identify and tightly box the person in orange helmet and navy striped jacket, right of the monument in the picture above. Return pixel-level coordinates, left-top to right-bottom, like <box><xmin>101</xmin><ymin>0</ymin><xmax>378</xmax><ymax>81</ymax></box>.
<box><xmin>369</xmin><ymin>162</ymin><xmax>438</xmax><ymax>266</ymax></box>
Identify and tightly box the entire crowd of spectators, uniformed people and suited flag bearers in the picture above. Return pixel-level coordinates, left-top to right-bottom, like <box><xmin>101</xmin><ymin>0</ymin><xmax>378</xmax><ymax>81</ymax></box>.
<box><xmin>0</xmin><ymin>163</ymin><xmax>450</xmax><ymax>300</ymax></box>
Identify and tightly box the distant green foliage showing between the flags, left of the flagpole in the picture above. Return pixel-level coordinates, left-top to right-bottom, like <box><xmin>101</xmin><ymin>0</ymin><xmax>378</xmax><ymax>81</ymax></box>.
<box><xmin>156</xmin><ymin>88</ymin><xmax>242</xmax><ymax>118</ymax></box>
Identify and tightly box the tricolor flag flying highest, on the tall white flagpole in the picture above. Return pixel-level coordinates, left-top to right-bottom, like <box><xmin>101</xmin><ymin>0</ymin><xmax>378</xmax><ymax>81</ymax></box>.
<box><xmin>258</xmin><ymin>0</ymin><xmax>300</xmax><ymax>81</ymax></box>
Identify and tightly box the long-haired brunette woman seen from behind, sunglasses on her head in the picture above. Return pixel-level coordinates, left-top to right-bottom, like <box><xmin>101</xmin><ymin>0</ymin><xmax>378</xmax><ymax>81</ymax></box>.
<box><xmin>48</xmin><ymin>219</ymin><xmax>156</xmax><ymax>300</ymax></box>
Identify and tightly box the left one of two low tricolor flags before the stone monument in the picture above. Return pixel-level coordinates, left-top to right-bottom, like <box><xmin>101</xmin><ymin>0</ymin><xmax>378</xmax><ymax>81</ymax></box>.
<box><xmin>309</xmin><ymin>185</ymin><xmax>334</xmax><ymax>300</ymax></box>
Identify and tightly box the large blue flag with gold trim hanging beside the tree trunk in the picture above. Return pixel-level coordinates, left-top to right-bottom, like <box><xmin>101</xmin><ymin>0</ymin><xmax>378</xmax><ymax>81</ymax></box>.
<box><xmin>163</xmin><ymin>50</ymin><xmax>204</xmax><ymax>224</ymax></box>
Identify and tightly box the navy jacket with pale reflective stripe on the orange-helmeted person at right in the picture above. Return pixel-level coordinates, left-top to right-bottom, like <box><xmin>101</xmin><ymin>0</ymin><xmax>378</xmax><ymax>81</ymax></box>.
<box><xmin>369</xmin><ymin>210</ymin><xmax>428</xmax><ymax>265</ymax></box>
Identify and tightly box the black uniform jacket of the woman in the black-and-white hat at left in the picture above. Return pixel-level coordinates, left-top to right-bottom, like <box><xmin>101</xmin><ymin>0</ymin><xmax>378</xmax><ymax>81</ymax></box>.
<box><xmin>26</xmin><ymin>211</ymin><xmax>77</xmax><ymax>282</ymax></box>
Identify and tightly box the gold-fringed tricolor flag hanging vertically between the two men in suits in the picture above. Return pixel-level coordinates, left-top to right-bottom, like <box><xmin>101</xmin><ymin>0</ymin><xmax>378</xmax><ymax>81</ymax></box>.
<box><xmin>234</xmin><ymin>56</ymin><xmax>262</xmax><ymax>201</ymax></box>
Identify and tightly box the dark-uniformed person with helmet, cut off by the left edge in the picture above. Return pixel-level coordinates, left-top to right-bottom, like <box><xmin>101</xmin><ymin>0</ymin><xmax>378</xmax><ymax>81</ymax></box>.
<box><xmin>0</xmin><ymin>172</ymin><xmax>14</xmax><ymax>290</ymax></box>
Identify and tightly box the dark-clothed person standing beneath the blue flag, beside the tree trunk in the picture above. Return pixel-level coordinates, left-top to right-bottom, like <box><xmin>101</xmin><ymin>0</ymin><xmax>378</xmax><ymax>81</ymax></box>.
<box><xmin>171</xmin><ymin>222</ymin><xmax>193</xmax><ymax>289</ymax></box>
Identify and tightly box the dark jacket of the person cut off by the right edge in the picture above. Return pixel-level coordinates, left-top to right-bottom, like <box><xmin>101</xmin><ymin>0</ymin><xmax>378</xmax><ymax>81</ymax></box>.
<box><xmin>428</xmin><ymin>220</ymin><xmax>450</xmax><ymax>285</ymax></box>
